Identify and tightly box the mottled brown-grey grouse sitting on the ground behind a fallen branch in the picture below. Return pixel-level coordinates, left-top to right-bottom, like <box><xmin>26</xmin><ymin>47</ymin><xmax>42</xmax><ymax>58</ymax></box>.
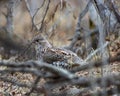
<box><xmin>33</xmin><ymin>36</ymin><xmax>83</xmax><ymax>69</ymax></box>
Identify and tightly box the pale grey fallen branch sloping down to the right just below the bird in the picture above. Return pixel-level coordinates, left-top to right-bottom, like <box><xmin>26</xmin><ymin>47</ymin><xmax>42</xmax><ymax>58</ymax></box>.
<box><xmin>0</xmin><ymin>61</ymin><xmax>76</xmax><ymax>79</ymax></box>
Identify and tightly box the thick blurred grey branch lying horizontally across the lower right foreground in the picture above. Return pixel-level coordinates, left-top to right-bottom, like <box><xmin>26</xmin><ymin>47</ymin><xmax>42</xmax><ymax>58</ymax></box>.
<box><xmin>46</xmin><ymin>74</ymin><xmax>120</xmax><ymax>89</ymax></box>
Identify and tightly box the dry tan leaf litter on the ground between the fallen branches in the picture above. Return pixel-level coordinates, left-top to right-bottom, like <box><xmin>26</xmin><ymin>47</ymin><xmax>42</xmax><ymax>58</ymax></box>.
<box><xmin>0</xmin><ymin>37</ymin><xmax>120</xmax><ymax>96</ymax></box>
